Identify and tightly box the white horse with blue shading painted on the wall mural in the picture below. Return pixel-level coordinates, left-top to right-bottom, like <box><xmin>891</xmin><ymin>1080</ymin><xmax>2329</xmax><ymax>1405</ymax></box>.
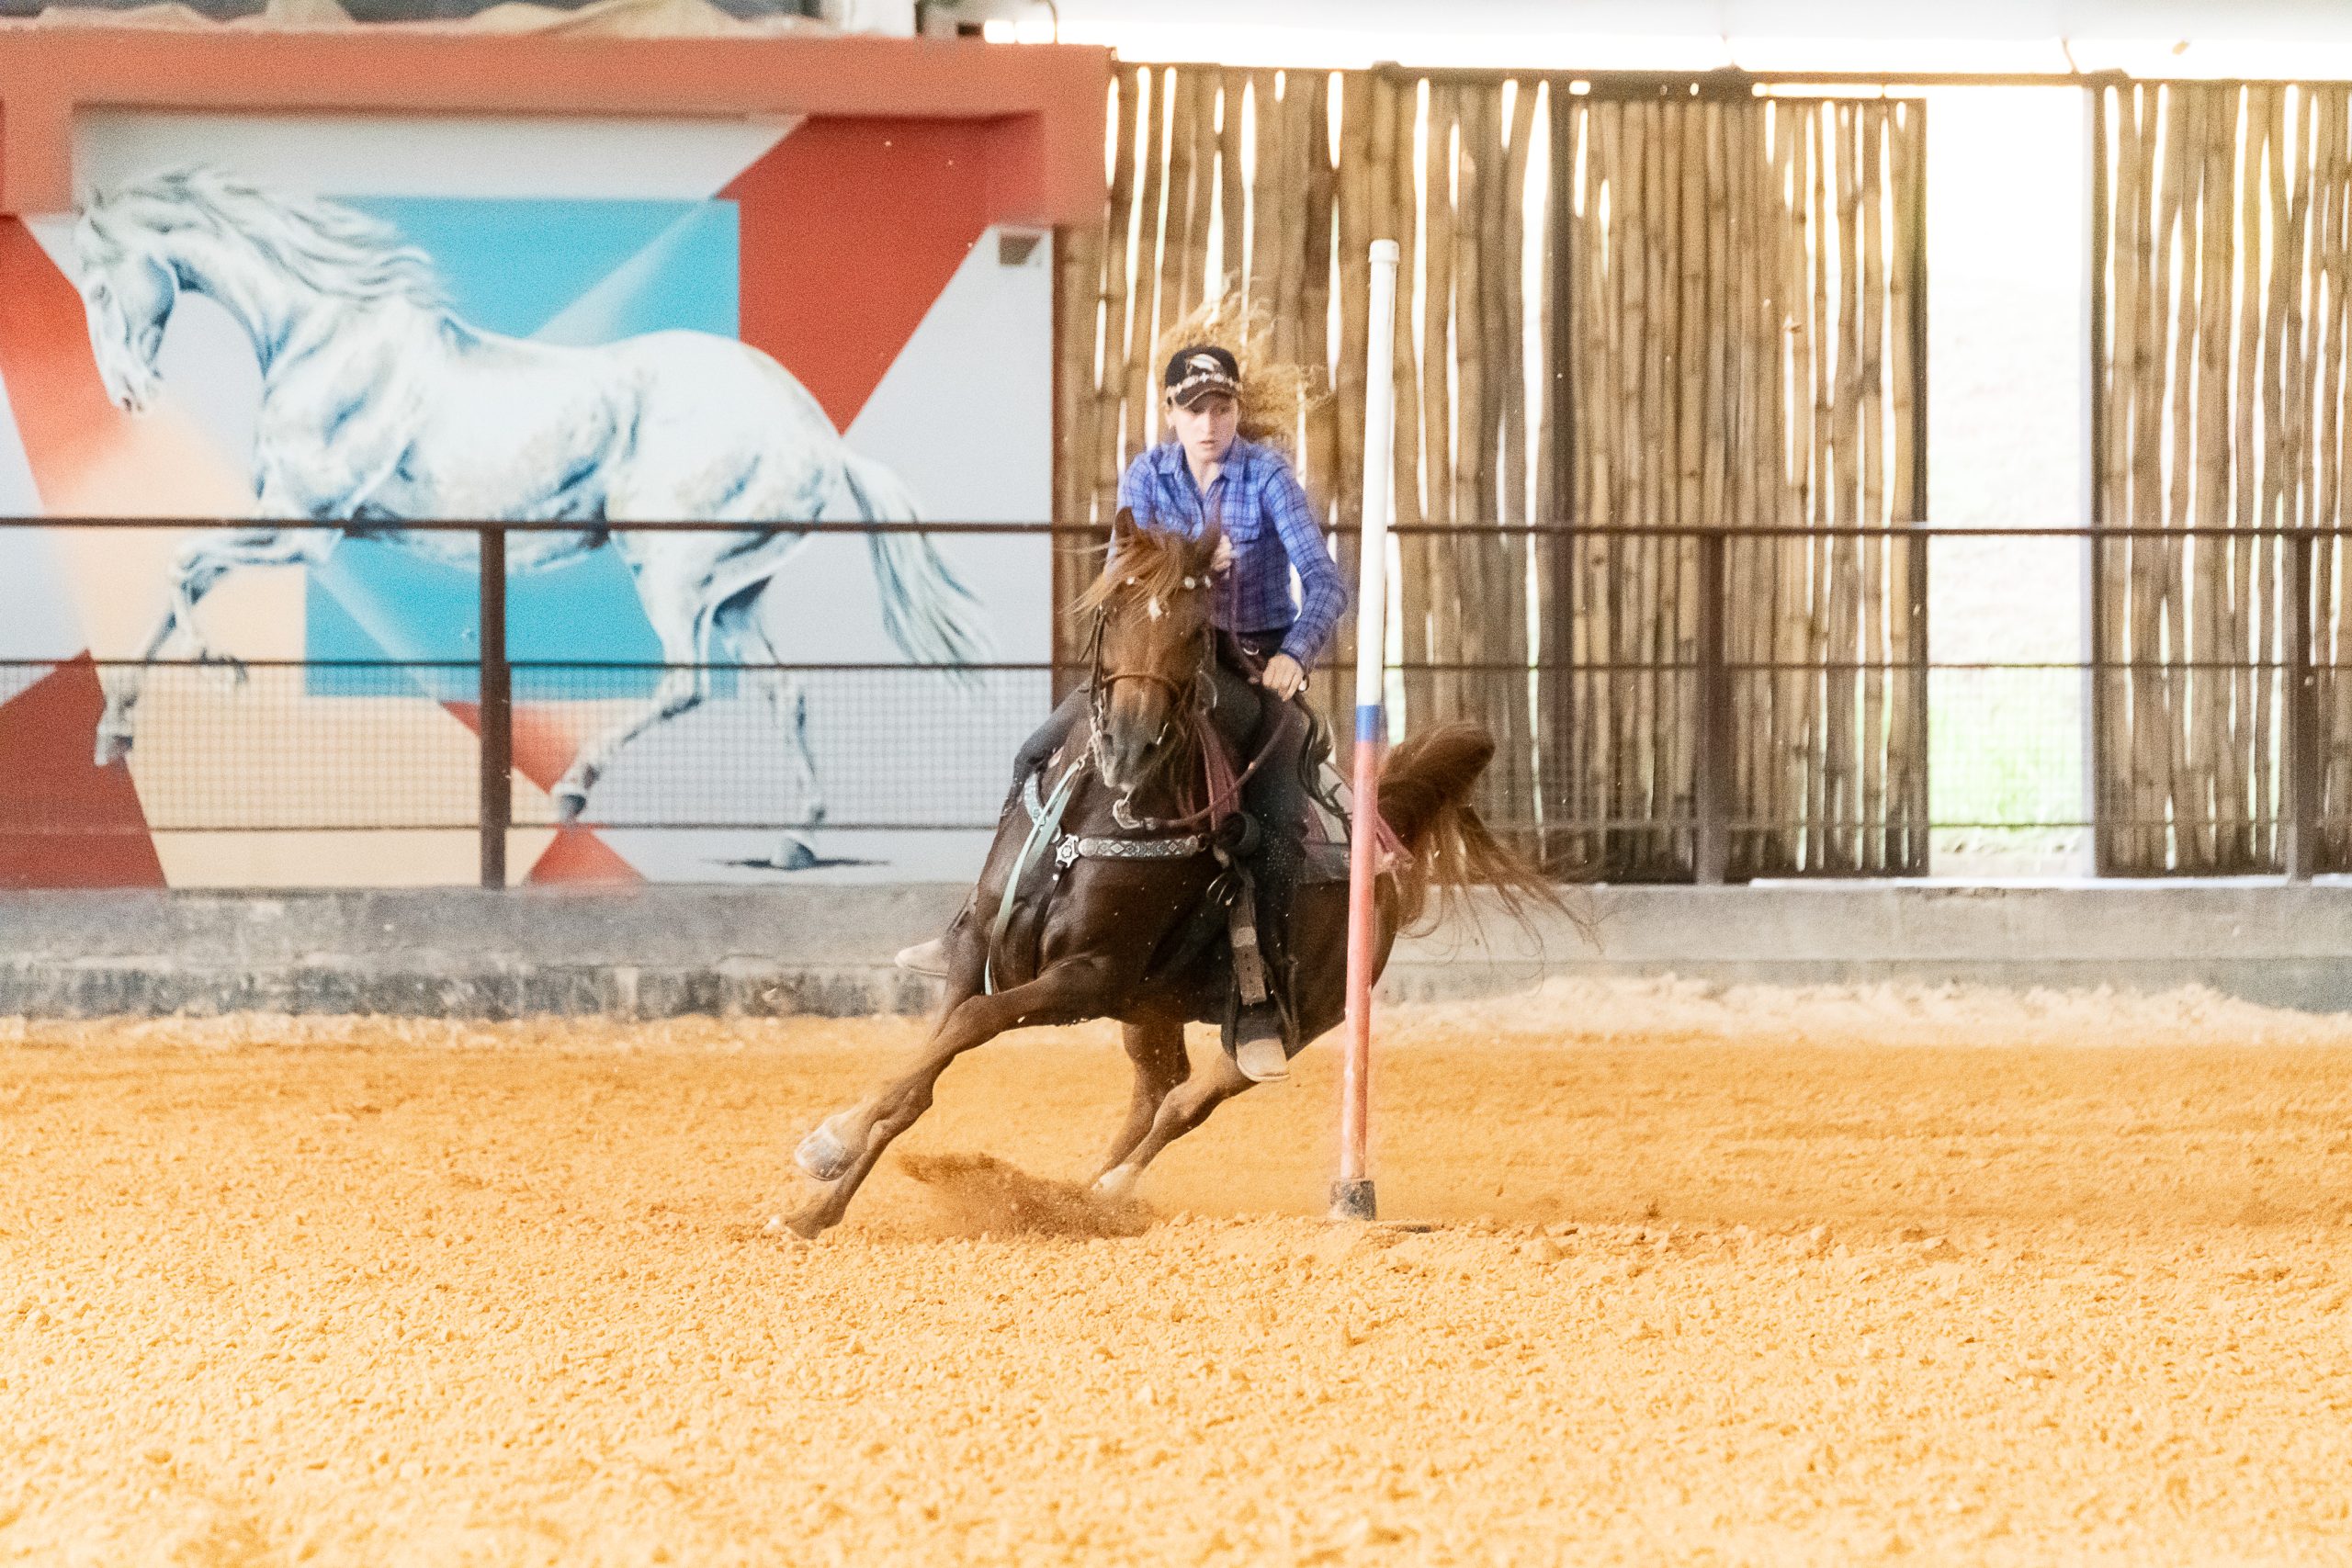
<box><xmin>75</xmin><ymin>169</ymin><xmax>983</xmax><ymax>865</ymax></box>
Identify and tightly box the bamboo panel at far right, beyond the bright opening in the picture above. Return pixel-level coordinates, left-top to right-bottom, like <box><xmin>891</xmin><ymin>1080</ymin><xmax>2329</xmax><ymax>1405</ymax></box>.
<box><xmin>2091</xmin><ymin>83</ymin><xmax>2352</xmax><ymax>874</ymax></box>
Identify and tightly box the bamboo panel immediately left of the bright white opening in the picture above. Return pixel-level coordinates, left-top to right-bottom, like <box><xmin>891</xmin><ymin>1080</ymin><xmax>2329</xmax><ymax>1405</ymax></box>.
<box><xmin>1557</xmin><ymin>94</ymin><xmax>1928</xmax><ymax>877</ymax></box>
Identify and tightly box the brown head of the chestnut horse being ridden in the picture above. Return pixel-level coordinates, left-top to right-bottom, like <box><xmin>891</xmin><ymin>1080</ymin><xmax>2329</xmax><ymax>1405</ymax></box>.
<box><xmin>1082</xmin><ymin>510</ymin><xmax>1218</xmax><ymax>790</ymax></box>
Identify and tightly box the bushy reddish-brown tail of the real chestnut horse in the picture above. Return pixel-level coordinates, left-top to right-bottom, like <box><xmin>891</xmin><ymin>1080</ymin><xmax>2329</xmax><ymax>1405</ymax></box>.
<box><xmin>1381</xmin><ymin>724</ymin><xmax>1583</xmax><ymax>931</ymax></box>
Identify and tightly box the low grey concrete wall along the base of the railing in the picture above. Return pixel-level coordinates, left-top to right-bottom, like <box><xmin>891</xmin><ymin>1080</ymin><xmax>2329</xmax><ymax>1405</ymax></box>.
<box><xmin>14</xmin><ymin>882</ymin><xmax>2352</xmax><ymax>1018</ymax></box>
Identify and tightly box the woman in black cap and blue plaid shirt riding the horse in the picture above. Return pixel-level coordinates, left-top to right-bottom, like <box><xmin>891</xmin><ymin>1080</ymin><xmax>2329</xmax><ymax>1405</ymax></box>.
<box><xmin>899</xmin><ymin>344</ymin><xmax>1348</xmax><ymax>1084</ymax></box>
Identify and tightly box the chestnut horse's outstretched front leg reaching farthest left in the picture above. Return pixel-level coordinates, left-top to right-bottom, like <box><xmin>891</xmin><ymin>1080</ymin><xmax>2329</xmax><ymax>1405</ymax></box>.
<box><xmin>786</xmin><ymin>959</ymin><xmax>1103</xmax><ymax>1239</ymax></box>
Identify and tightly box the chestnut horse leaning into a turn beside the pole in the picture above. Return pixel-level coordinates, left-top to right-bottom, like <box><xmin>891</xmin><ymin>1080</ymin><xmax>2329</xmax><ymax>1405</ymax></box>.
<box><xmin>786</xmin><ymin>513</ymin><xmax>1562</xmax><ymax>1236</ymax></box>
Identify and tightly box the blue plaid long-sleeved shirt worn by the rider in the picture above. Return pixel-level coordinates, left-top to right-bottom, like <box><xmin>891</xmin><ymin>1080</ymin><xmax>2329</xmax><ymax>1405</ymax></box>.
<box><xmin>1120</xmin><ymin>437</ymin><xmax>1348</xmax><ymax>668</ymax></box>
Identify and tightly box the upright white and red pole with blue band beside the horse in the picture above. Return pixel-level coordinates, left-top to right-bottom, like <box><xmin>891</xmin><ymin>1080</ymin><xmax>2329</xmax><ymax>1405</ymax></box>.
<box><xmin>1331</xmin><ymin>240</ymin><xmax>1397</xmax><ymax>1220</ymax></box>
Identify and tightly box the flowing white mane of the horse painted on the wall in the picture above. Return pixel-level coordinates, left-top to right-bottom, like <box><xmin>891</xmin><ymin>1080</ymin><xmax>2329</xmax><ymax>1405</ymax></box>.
<box><xmin>80</xmin><ymin>164</ymin><xmax>449</xmax><ymax>310</ymax></box>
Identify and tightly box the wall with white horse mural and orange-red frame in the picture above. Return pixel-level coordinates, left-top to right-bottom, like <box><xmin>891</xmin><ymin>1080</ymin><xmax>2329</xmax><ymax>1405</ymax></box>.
<box><xmin>0</xmin><ymin>24</ymin><xmax>1108</xmax><ymax>888</ymax></box>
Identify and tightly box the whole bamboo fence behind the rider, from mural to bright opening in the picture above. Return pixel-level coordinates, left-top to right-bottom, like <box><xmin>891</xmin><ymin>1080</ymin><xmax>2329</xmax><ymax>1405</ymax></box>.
<box><xmin>1056</xmin><ymin>66</ymin><xmax>1927</xmax><ymax>879</ymax></box>
